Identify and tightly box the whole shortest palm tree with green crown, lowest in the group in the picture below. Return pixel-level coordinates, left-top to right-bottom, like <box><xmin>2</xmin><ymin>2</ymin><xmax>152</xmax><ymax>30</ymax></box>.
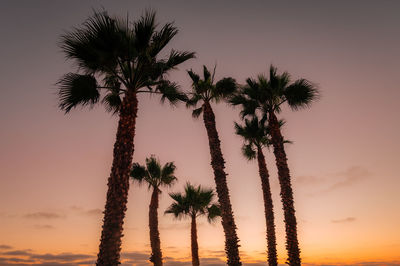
<box><xmin>165</xmin><ymin>183</ymin><xmax>221</xmax><ymax>266</ymax></box>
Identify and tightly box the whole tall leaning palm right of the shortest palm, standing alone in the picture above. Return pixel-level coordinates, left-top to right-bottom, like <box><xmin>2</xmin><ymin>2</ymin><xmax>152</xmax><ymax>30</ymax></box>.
<box><xmin>186</xmin><ymin>66</ymin><xmax>241</xmax><ymax>266</ymax></box>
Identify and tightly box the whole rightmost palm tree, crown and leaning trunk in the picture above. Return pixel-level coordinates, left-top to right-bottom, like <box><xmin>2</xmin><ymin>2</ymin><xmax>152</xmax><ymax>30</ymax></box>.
<box><xmin>230</xmin><ymin>66</ymin><xmax>319</xmax><ymax>265</ymax></box>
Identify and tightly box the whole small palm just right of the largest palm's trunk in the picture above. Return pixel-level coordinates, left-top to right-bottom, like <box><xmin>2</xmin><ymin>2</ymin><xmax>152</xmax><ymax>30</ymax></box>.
<box><xmin>131</xmin><ymin>155</ymin><xmax>177</xmax><ymax>266</ymax></box>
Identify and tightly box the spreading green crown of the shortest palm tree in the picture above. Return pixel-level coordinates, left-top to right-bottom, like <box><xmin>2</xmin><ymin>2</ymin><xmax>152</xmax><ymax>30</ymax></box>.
<box><xmin>165</xmin><ymin>183</ymin><xmax>221</xmax><ymax>222</ymax></box>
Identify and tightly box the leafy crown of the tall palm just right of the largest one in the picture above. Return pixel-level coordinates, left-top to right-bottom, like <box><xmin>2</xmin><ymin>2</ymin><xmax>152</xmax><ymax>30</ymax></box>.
<box><xmin>186</xmin><ymin>66</ymin><xmax>237</xmax><ymax>118</ymax></box>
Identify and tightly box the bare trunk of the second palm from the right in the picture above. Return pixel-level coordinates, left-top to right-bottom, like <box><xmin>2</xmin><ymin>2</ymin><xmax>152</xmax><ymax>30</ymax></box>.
<box><xmin>257</xmin><ymin>147</ymin><xmax>278</xmax><ymax>266</ymax></box>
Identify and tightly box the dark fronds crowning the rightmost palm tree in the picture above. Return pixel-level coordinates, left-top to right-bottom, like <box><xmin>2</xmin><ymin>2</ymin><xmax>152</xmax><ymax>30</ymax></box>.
<box><xmin>230</xmin><ymin>65</ymin><xmax>319</xmax><ymax>120</ymax></box>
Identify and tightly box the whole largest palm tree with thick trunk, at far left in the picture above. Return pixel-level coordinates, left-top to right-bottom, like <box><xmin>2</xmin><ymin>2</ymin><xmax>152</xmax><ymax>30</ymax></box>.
<box><xmin>57</xmin><ymin>11</ymin><xmax>194</xmax><ymax>265</ymax></box>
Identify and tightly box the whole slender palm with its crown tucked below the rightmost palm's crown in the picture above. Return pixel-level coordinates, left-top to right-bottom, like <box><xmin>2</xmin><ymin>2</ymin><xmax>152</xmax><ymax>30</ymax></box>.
<box><xmin>235</xmin><ymin>117</ymin><xmax>278</xmax><ymax>266</ymax></box>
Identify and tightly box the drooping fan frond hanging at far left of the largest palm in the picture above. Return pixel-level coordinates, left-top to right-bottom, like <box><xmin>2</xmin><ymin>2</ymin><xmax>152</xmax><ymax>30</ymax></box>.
<box><xmin>57</xmin><ymin>73</ymin><xmax>100</xmax><ymax>113</ymax></box>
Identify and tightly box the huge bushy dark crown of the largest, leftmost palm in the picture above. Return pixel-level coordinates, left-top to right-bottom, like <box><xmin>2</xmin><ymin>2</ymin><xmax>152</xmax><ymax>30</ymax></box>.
<box><xmin>57</xmin><ymin>11</ymin><xmax>194</xmax><ymax>113</ymax></box>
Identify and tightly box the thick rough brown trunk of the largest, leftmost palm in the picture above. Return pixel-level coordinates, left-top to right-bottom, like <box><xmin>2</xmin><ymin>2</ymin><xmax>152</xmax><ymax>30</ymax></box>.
<box><xmin>96</xmin><ymin>91</ymin><xmax>138</xmax><ymax>266</ymax></box>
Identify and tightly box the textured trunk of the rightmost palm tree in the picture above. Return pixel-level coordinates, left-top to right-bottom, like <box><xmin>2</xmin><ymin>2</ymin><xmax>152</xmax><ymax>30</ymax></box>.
<box><xmin>269</xmin><ymin>112</ymin><xmax>301</xmax><ymax>266</ymax></box>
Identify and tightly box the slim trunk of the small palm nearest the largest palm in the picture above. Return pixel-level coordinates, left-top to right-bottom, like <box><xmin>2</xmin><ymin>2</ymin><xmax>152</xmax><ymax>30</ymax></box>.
<box><xmin>149</xmin><ymin>188</ymin><xmax>162</xmax><ymax>266</ymax></box>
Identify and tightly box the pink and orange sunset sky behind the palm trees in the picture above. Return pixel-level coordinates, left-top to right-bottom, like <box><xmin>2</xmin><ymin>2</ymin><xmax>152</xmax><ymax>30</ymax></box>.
<box><xmin>0</xmin><ymin>0</ymin><xmax>400</xmax><ymax>266</ymax></box>
